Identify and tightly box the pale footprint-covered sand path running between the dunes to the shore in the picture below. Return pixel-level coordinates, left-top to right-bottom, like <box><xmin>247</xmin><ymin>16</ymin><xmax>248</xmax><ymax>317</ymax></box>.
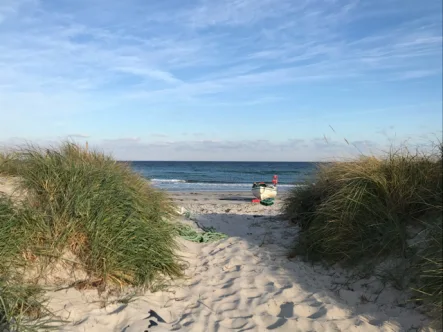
<box><xmin>0</xmin><ymin>183</ymin><xmax>436</xmax><ymax>332</ymax></box>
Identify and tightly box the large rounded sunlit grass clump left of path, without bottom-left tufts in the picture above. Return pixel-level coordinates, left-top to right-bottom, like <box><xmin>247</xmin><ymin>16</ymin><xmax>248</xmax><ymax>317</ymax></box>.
<box><xmin>2</xmin><ymin>143</ymin><xmax>181</xmax><ymax>287</ymax></box>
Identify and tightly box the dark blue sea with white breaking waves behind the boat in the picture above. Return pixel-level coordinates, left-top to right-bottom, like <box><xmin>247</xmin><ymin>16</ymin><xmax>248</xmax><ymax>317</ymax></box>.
<box><xmin>126</xmin><ymin>161</ymin><xmax>315</xmax><ymax>191</ymax></box>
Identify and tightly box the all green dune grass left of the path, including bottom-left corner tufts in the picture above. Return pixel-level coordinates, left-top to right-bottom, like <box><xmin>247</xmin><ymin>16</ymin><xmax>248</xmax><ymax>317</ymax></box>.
<box><xmin>0</xmin><ymin>143</ymin><xmax>182</xmax><ymax>331</ymax></box>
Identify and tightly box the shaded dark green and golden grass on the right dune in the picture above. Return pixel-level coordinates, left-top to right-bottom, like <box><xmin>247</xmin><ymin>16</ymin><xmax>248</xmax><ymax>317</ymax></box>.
<box><xmin>284</xmin><ymin>144</ymin><xmax>443</xmax><ymax>320</ymax></box>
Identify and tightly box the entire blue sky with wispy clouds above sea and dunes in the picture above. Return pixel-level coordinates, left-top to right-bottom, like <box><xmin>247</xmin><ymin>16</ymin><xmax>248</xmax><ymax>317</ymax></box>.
<box><xmin>0</xmin><ymin>0</ymin><xmax>442</xmax><ymax>161</ymax></box>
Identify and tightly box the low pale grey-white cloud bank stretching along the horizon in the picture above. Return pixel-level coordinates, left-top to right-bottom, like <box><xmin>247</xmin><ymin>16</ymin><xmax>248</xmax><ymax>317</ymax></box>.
<box><xmin>0</xmin><ymin>130</ymin><xmax>441</xmax><ymax>161</ymax></box>
